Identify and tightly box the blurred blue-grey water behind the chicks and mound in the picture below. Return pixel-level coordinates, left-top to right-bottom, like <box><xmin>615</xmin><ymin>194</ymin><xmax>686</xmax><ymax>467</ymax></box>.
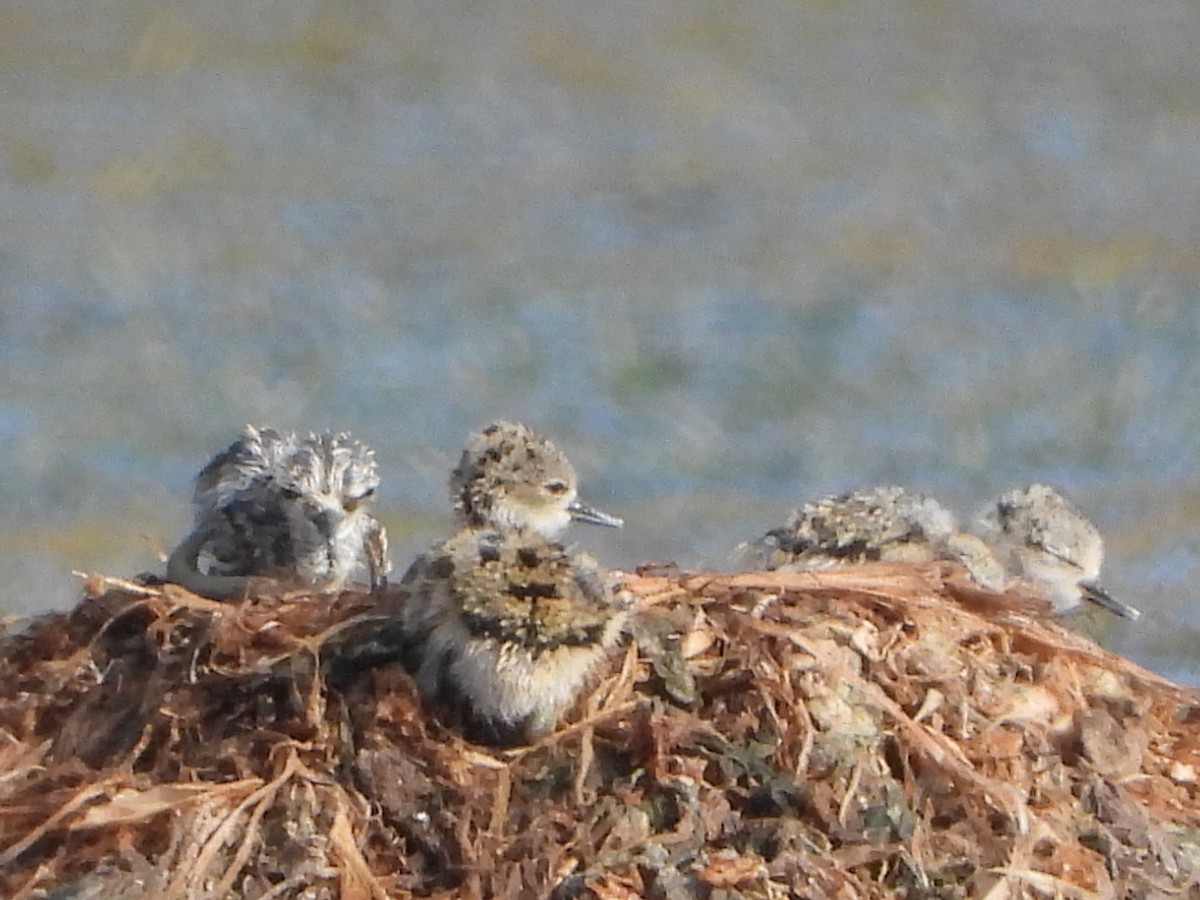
<box><xmin>0</xmin><ymin>0</ymin><xmax>1200</xmax><ymax>683</ymax></box>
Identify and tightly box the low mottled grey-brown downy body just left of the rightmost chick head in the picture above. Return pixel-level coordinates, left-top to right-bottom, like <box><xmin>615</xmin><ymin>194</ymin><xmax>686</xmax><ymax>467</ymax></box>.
<box><xmin>754</xmin><ymin>485</ymin><xmax>1004</xmax><ymax>590</ymax></box>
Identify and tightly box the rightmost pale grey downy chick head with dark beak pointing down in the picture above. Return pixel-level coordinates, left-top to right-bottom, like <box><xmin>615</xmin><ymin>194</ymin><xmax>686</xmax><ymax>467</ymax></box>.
<box><xmin>985</xmin><ymin>484</ymin><xmax>1141</xmax><ymax>619</ymax></box>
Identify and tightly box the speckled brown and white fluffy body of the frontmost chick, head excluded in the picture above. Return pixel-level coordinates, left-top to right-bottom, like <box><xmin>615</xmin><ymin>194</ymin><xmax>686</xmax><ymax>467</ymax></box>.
<box><xmin>400</xmin><ymin>529</ymin><xmax>630</xmax><ymax>743</ymax></box>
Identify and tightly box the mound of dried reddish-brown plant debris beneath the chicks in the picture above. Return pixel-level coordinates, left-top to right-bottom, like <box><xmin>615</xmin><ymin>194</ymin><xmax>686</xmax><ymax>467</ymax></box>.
<box><xmin>0</xmin><ymin>564</ymin><xmax>1200</xmax><ymax>900</ymax></box>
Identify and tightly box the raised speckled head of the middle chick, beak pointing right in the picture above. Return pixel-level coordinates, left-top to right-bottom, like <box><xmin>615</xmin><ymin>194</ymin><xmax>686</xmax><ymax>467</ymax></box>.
<box><xmin>450</xmin><ymin>421</ymin><xmax>624</xmax><ymax>540</ymax></box>
